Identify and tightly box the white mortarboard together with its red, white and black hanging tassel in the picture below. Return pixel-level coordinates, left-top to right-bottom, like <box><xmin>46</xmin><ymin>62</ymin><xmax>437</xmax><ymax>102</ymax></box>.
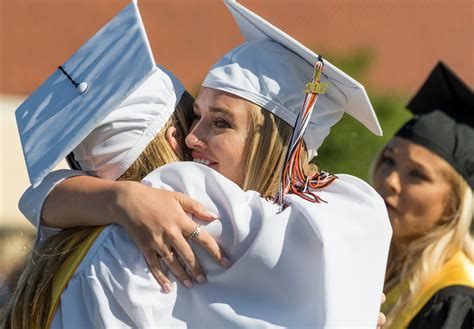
<box><xmin>203</xmin><ymin>0</ymin><xmax>382</xmax><ymax>207</ymax></box>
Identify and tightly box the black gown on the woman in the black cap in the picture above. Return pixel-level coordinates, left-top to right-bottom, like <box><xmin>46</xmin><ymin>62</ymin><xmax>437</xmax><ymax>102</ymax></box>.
<box><xmin>408</xmin><ymin>286</ymin><xmax>474</xmax><ymax>329</ymax></box>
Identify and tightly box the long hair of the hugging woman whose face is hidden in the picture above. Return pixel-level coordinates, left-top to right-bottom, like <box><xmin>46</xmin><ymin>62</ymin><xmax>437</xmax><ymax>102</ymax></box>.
<box><xmin>0</xmin><ymin>92</ymin><xmax>194</xmax><ymax>329</ymax></box>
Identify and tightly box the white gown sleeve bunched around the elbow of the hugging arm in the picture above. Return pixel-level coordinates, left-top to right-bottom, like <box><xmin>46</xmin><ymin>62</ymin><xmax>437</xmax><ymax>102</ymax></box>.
<box><xmin>18</xmin><ymin>169</ymin><xmax>87</xmax><ymax>245</ymax></box>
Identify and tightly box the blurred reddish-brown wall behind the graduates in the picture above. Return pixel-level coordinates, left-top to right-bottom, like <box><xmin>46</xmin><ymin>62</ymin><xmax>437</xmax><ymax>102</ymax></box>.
<box><xmin>0</xmin><ymin>0</ymin><xmax>474</xmax><ymax>94</ymax></box>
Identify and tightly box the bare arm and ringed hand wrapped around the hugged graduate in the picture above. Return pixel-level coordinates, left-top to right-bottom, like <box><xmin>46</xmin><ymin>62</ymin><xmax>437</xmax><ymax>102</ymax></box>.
<box><xmin>41</xmin><ymin>176</ymin><xmax>230</xmax><ymax>292</ymax></box>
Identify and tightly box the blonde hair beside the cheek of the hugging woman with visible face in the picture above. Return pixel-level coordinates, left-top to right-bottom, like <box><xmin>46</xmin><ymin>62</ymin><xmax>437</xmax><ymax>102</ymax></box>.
<box><xmin>242</xmin><ymin>104</ymin><xmax>318</xmax><ymax>198</ymax></box>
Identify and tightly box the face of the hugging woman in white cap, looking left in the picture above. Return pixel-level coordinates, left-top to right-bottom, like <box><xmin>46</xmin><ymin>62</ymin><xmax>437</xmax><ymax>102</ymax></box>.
<box><xmin>186</xmin><ymin>87</ymin><xmax>252</xmax><ymax>186</ymax></box>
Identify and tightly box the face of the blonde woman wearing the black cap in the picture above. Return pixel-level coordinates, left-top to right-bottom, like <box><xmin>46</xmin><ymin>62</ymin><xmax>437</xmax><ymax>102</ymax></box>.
<box><xmin>374</xmin><ymin>137</ymin><xmax>452</xmax><ymax>244</ymax></box>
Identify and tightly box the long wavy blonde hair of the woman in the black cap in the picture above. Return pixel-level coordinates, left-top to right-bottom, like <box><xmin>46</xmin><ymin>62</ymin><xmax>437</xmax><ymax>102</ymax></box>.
<box><xmin>371</xmin><ymin>145</ymin><xmax>474</xmax><ymax>328</ymax></box>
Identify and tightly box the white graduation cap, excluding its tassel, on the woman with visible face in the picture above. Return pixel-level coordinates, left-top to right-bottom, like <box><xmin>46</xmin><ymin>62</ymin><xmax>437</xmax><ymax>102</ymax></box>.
<box><xmin>202</xmin><ymin>0</ymin><xmax>382</xmax><ymax>158</ymax></box>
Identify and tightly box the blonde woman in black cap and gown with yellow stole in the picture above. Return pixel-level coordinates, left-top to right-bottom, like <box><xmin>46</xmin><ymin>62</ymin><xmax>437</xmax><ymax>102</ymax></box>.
<box><xmin>373</xmin><ymin>62</ymin><xmax>474</xmax><ymax>329</ymax></box>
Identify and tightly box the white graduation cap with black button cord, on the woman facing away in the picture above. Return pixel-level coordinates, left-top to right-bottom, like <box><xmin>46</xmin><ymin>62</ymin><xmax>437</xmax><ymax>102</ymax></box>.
<box><xmin>16</xmin><ymin>1</ymin><xmax>184</xmax><ymax>187</ymax></box>
